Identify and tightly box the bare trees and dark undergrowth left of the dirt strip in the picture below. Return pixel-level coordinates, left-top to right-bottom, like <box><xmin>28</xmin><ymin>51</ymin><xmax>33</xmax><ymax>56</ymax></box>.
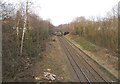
<box><xmin>0</xmin><ymin>2</ymin><xmax>53</xmax><ymax>82</ymax></box>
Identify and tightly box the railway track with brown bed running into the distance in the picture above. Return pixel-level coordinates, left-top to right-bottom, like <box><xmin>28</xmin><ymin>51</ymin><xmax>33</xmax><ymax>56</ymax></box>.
<box><xmin>58</xmin><ymin>37</ymin><xmax>114</xmax><ymax>84</ymax></box>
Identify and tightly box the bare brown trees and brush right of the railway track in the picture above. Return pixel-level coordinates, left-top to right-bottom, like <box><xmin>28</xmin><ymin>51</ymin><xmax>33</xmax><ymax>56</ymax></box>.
<box><xmin>61</xmin><ymin>5</ymin><xmax>118</xmax><ymax>53</ymax></box>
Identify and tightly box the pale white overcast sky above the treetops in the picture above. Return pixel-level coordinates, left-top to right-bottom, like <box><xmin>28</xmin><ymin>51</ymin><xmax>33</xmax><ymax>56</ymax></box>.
<box><xmin>4</xmin><ymin>0</ymin><xmax>120</xmax><ymax>26</ymax></box>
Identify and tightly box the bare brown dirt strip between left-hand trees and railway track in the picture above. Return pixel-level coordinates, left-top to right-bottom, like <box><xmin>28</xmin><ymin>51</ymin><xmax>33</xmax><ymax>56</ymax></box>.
<box><xmin>33</xmin><ymin>36</ymin><xmax>71</xmax><ymax>82</ymax></box>
